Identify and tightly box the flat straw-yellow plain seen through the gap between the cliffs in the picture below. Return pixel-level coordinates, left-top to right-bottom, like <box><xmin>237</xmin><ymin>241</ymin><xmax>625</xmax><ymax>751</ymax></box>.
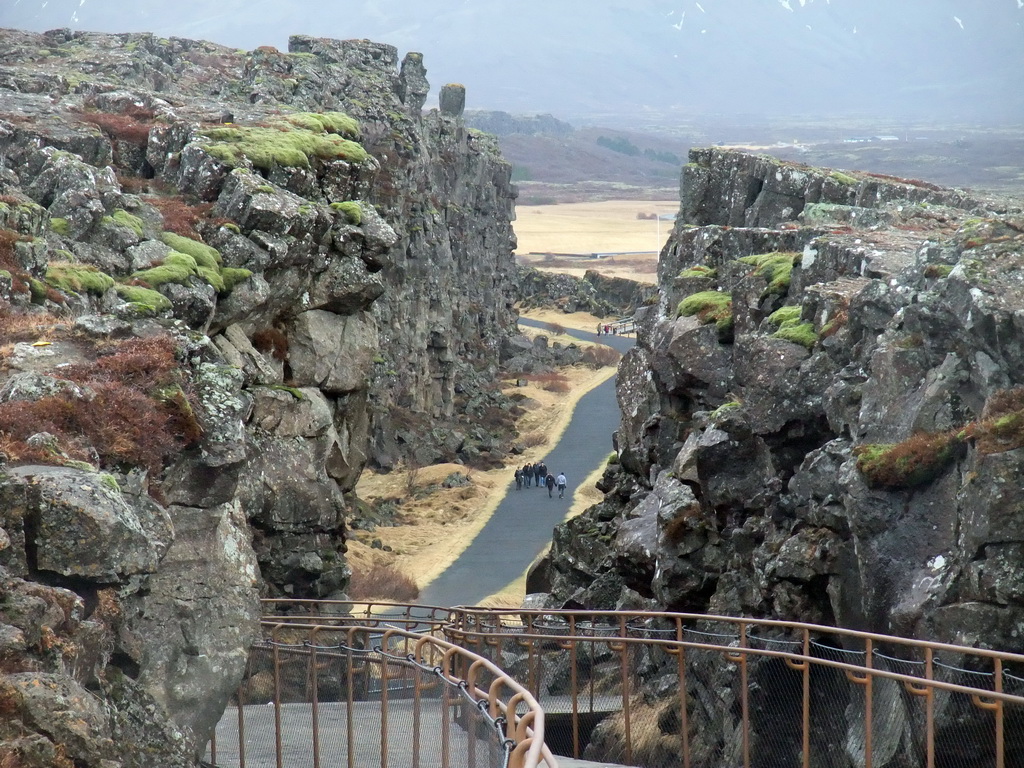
<box><xmin>513</xmin><ymin>200</ymin><xmax>679</xmax><ymax>283</ymax></box>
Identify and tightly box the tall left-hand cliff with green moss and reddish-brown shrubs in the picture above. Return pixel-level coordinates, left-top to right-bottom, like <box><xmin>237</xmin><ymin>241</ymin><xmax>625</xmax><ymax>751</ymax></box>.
<box><xmin>0</xmin><ymin>31</ymin><xmax>514</xmax><ymax>766</ymax></box>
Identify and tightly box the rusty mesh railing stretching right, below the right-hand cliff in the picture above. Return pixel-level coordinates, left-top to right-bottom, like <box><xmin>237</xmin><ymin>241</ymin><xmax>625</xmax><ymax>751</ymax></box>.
<box><xmin>445</xmin><ymin>608</ymin><xmax>1024</xmax><ymax>768</ymax></box>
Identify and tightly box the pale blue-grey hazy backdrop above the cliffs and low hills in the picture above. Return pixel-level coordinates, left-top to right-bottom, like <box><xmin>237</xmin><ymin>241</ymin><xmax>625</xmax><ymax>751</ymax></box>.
<box><xmin>0</xmin><ymin>0</ymin><xmax>1024</xmax><ymax>127</ymax></box>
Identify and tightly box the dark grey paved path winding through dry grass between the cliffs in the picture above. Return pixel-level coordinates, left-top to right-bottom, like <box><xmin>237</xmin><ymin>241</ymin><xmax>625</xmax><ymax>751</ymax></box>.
<box><xmin>419</xmin><ymin>318</ymin><xmax>634</xmax><ymax>605</ymax></box>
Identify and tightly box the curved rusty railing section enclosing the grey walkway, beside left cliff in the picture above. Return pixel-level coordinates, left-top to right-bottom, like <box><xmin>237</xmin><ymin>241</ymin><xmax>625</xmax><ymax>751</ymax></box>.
<box><xmin>208</xmin><ymin>618</ymin><xmax>557</xmax><ymax>768</ymax></box>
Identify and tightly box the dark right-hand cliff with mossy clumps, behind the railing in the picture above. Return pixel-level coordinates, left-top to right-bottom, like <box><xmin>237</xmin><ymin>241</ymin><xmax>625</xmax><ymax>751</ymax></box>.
<box><xmin>548</xmin><ymin>151</ymin><xmax>1024</xmax><ymax>650</ymax></box>
